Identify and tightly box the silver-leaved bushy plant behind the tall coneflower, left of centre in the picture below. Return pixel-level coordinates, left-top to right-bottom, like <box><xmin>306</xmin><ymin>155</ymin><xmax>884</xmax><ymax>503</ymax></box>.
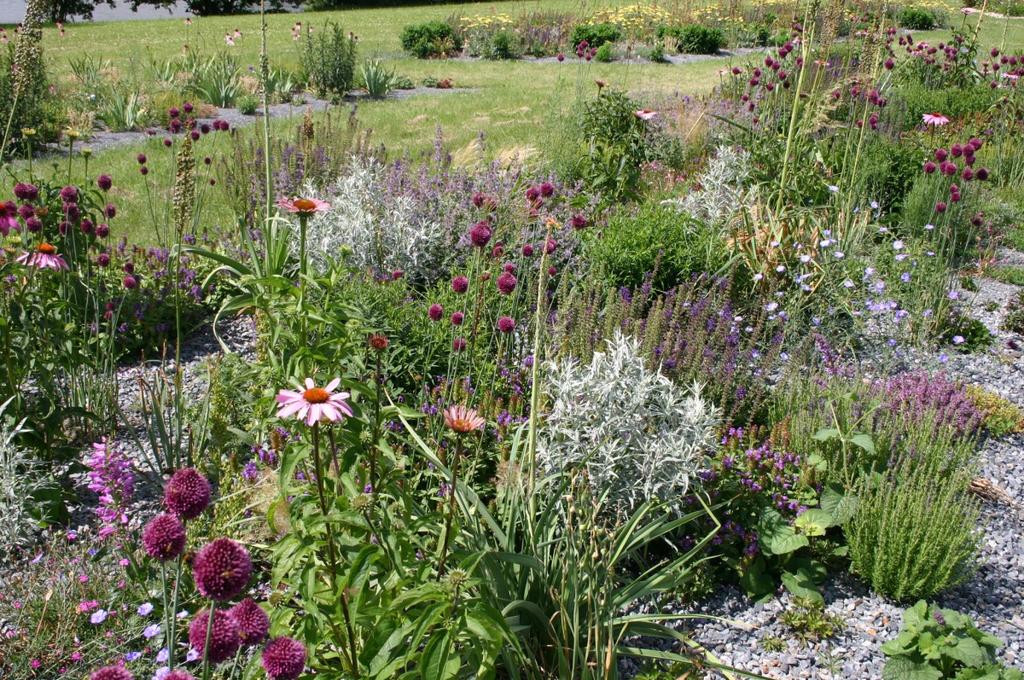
<box><xmin>296</xmin><ymin>158</ymin><xmax>447</xmax><ymax>281</ymax></box>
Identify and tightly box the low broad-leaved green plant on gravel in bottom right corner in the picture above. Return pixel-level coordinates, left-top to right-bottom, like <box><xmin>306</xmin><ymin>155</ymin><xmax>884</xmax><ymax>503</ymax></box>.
<box><xmin>882</xmin><ymin>600</ymin><xmax>1024</xmax><ymax>680</ymax></box>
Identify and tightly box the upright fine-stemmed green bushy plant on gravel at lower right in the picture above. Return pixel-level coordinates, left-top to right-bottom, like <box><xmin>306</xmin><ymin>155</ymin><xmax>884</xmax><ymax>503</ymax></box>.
<box><xmin>845</xmin><ymin>440</ymin><xmax>980</xmax><ymax>601</ymax></box>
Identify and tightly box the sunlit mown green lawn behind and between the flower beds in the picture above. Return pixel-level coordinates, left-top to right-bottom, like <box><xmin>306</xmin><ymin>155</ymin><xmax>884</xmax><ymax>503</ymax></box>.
<box><xmin>12</xmin><ymin>0</ymin><xmax>1024</xmax><ymax>242</ymax></box>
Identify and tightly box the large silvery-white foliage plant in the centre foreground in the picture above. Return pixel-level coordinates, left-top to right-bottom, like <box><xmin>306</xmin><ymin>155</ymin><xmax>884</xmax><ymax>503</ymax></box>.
<box><xmin>538</xmin><ymin>331</ymin><xmax>721</xmax><ymax>513</ymax></box>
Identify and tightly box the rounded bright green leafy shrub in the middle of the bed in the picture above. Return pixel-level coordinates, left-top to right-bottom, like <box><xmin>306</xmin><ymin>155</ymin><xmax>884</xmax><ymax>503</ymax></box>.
<box><xmin>585</xmin><ymin>204</ymin><xmax>728</xmax><ymax>290</ymax></box>
